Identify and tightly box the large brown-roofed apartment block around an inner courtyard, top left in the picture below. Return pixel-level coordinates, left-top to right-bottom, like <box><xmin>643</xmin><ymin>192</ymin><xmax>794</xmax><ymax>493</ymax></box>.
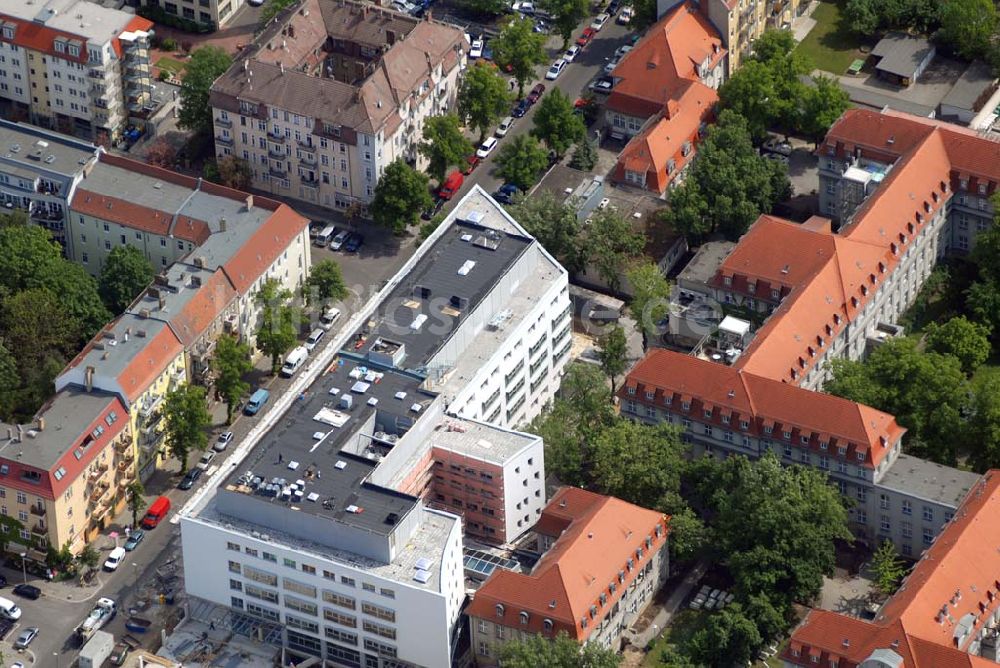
<box><xmin>210</xmin><ymin>0</ymin><xmax>468</xmax><ymax>209</ymax></box>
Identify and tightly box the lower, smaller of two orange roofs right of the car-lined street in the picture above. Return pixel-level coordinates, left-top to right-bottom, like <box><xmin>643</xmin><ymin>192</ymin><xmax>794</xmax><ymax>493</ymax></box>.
<box><xmin>614</xmin><ymin>81</ymin><xmax>719</xmax><ymax>193</ymax></box>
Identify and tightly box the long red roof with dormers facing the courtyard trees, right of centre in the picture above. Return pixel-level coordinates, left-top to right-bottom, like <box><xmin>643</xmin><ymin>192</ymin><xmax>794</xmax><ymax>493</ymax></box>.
<box><xmin>618</xmin><ymin>349</ymin><xmax>905</xmax><ymax>466</ymax></box>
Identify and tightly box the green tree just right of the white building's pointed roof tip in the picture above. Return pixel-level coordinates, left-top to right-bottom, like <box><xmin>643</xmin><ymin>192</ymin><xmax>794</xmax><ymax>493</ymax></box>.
<box><xmin>510</xmin><ymin>192</ymin><xmax>585</xmax><ymax>274</ymax></box>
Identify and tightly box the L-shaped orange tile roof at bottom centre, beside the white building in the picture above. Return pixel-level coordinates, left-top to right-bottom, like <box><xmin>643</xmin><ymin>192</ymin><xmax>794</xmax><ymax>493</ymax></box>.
<box><xmin>466</xmin><ymin>487</ymin><xmax>667</xmax><ymax>642</ymax></box>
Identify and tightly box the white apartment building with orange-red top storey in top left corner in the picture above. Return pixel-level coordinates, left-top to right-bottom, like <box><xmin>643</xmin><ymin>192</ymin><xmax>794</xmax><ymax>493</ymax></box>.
<box><xmin>0</xmin><ymin>0</ymin><xmax>153</xmax><ymax>144</ymax></box>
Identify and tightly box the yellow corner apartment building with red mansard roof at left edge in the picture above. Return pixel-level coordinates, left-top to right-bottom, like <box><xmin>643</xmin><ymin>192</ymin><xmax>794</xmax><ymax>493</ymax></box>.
<box><xmin>0</xmin><ymin>386</ymin><xmax>136</xmax><ymax>563</ymax></box>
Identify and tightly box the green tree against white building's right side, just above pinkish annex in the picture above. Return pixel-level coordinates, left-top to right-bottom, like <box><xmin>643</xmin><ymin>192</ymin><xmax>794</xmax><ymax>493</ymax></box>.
<box><xmin>528</xmin><ymin>363</ymin><xmax>617</xmax><ymax>487</ymax></box>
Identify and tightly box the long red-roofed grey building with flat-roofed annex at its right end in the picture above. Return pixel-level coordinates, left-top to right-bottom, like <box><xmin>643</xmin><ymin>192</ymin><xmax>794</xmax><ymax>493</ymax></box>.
<box><xmin>619</xmin><ymin>350</ymin><xmax>979</xmax><ymax>558</ymax></box>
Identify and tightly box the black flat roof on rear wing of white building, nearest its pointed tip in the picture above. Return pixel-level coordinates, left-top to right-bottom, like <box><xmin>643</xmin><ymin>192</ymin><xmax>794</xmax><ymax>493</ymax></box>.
<box><xmin>348</xmin><ymin>220</ymin><xmax>532</xmax><ymax>372</ymax></box>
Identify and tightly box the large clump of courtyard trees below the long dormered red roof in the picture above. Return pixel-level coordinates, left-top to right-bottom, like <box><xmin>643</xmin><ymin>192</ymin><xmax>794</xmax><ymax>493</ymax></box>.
<box><xmin>530</xmin><ymin>364</ymin><xmax>851</xmax><ymax>665</ymax></box>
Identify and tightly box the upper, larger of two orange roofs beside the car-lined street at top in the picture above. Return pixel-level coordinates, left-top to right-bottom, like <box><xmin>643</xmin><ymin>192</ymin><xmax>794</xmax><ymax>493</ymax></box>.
<box><xmin>607</xmin><ymin>3</ymin><xmax>726</xmax><ymax>118</ymax></box>
